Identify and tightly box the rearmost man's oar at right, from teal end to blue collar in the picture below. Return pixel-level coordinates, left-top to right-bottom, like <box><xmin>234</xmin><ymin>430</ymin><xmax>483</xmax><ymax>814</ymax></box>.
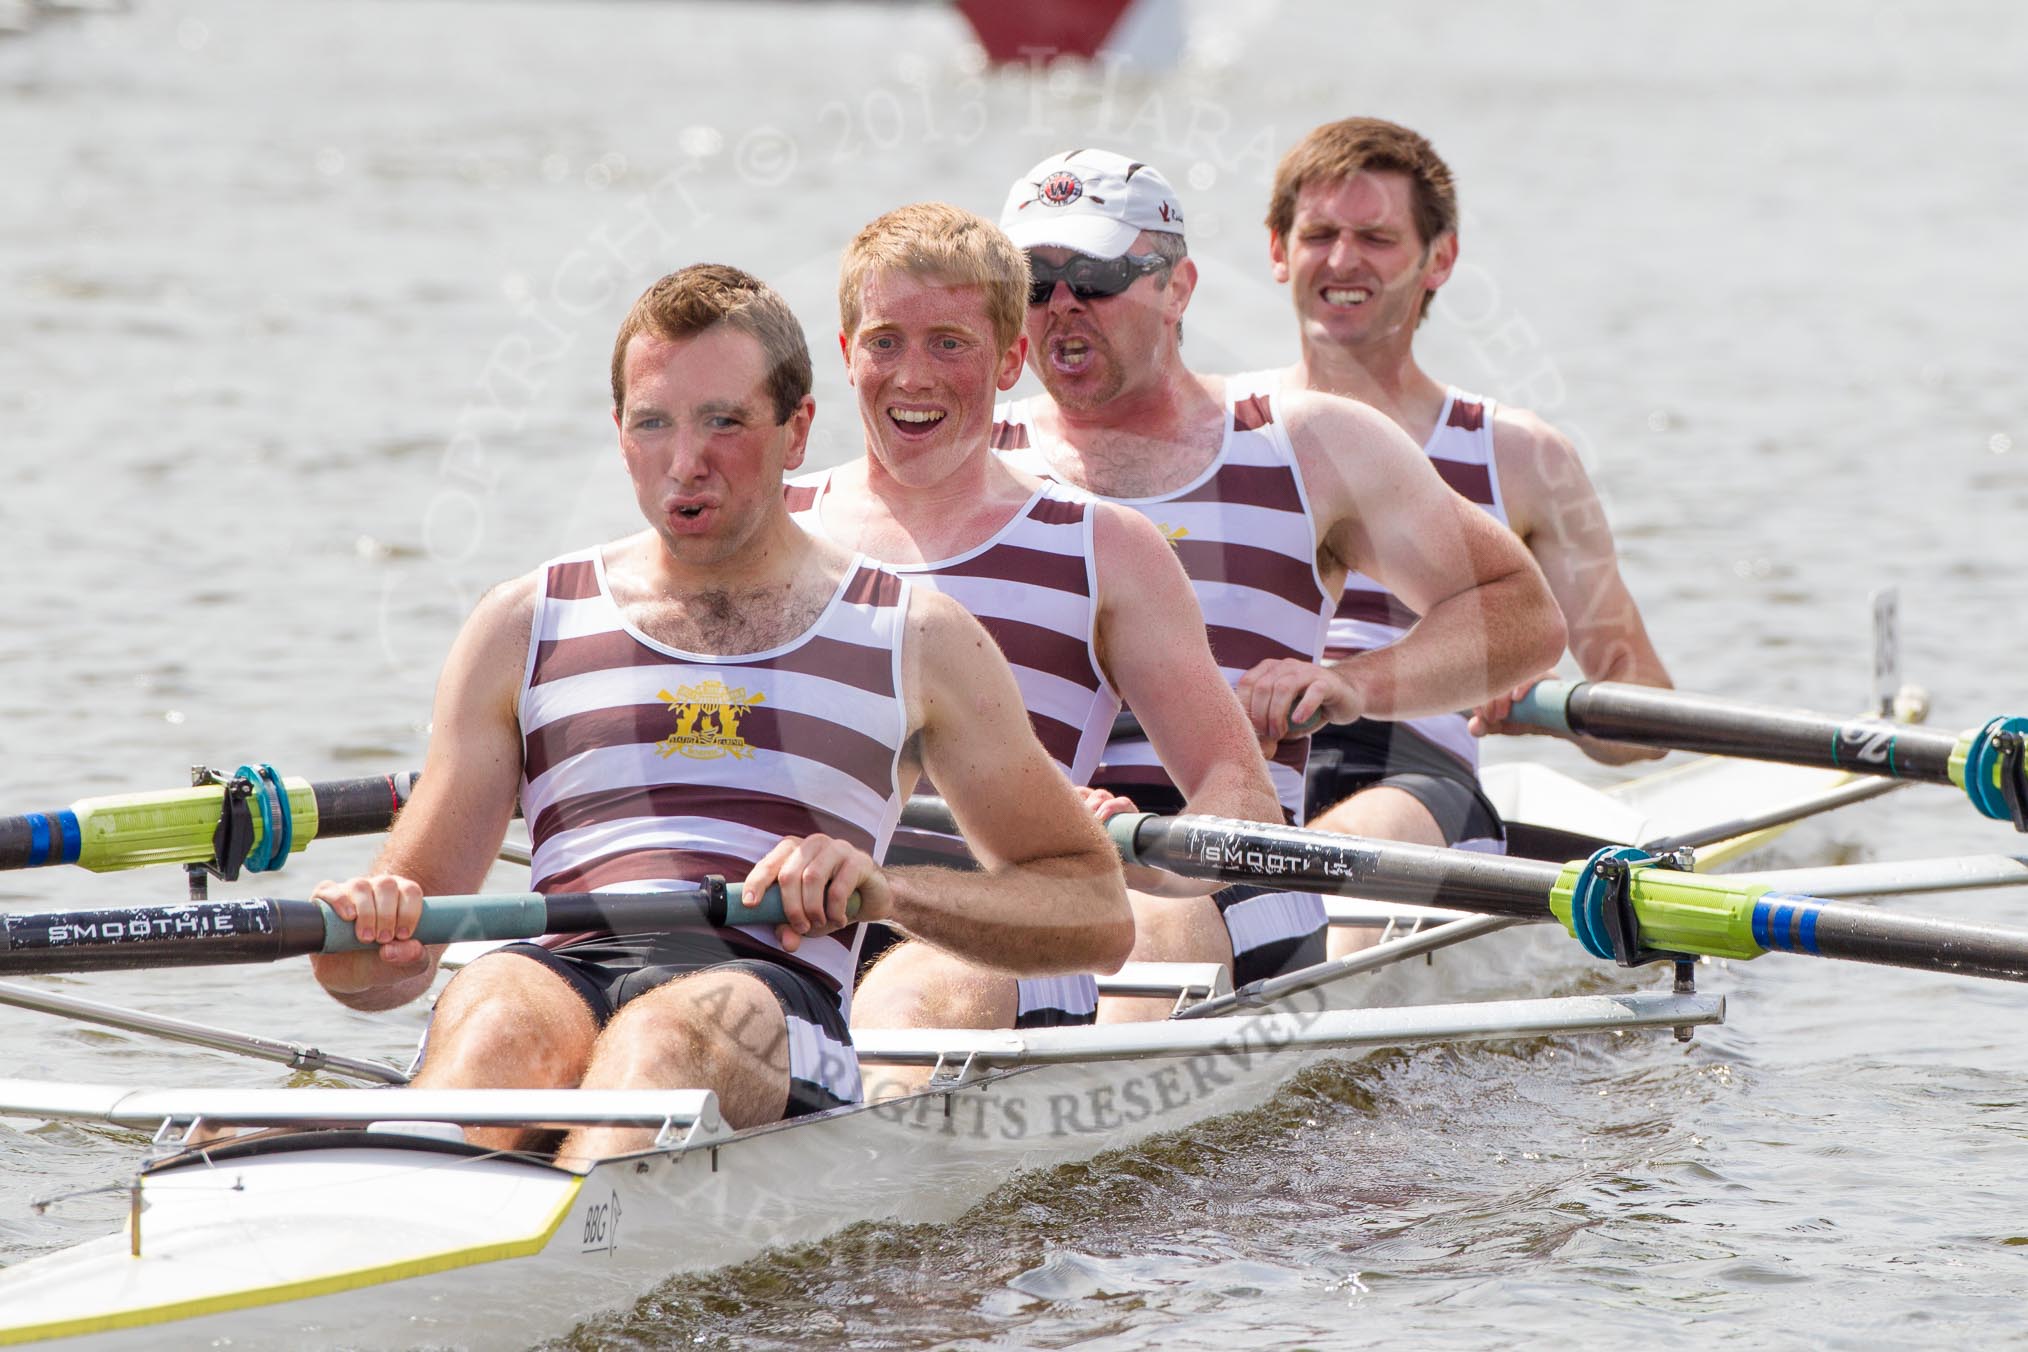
<box><xmin>1507</xmin><ymin>681</ymin><xmax>2028</xmax><ymax>831</ymax></box>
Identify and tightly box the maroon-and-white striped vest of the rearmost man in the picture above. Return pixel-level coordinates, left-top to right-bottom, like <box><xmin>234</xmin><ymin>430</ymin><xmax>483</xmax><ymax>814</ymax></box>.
<box><xmin>1324</xmin><ymin>385</ymin><xmax>1507</xmax><ymax>770</ymax></box>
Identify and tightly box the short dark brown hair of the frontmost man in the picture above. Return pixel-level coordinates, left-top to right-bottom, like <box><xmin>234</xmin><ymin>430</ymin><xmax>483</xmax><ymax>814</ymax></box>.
<box><xmin>612</xmin><ymin>264</ymin><xmax>809</xmax><ymax>424</ymax></box>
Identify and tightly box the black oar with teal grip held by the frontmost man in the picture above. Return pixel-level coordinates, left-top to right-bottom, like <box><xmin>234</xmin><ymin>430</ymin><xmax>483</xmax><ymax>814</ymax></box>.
<box><xmin>0</xmin><ymin>878</ymin><xmax>860</xmax><ymax>975</ymax></box>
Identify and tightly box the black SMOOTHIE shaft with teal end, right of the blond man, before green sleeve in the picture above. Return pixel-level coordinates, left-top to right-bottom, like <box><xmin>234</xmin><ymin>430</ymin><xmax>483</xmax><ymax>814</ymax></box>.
<box><xmin>1132</xmin><ymin>817</ymin><xmax>1562</xmax><ymax>918</ymax></box>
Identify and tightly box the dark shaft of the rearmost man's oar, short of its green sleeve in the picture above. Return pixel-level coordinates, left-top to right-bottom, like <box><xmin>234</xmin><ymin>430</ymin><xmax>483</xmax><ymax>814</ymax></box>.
<box><xmin>1511</xmin><ymin>681</ymin><xmax>1959</xmax><ymax>784</ymax></box>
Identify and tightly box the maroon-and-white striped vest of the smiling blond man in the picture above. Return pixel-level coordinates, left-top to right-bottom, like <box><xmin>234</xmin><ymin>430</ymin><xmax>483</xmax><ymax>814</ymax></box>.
<box><xmin>785</xmin><ymin>470</ymin><xmax>1119</xmax><ymax>784</ymax></box>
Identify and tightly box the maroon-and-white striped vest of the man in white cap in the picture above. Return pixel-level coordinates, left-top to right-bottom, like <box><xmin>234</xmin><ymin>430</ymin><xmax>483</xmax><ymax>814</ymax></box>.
<box><xmin>994</xmin><ymin>381</ymin><xmax>1330</xmax><ymax>823</ymax></box>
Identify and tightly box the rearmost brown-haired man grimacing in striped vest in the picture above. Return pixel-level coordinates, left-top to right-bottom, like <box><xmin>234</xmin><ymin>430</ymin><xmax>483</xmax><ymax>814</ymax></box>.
<box><xmin>1249</xmin><ymin>118</ymin><xmax>1669</xmax><ymax>932</ymax></box>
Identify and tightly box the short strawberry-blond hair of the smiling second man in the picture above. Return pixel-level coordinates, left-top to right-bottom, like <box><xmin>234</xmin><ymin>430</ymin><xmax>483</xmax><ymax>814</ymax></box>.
<box><xmin>838</xmin><ymin>203</ymin><xmax>1028</xmax><ymax>351</ymax></box>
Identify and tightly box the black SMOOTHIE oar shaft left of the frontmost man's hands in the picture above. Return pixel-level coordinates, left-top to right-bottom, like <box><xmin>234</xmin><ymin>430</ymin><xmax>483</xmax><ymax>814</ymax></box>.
<box><xmin>0</xmin><ymin>898</ymin><xmax>324</xmax><ymax>975</ymax></box>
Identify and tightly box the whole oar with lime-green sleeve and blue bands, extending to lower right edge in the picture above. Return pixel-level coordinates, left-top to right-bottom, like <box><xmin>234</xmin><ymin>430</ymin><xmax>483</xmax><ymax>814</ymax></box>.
<box><xmin>1105</xmin><ymin>815</ymin><xmax>2028</xmax><ymax>981</ymax></box>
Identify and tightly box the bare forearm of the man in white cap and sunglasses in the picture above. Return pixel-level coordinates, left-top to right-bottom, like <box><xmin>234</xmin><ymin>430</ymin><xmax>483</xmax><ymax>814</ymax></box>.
<box><xmin>1332</xmin><ymin>574</ymin><xmax>1564</xmax><ymax>722</ymax></box>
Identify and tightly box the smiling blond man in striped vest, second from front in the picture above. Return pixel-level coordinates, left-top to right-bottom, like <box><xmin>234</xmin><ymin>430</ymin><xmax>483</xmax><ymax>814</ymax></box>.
<box><xmin>787</xmin><ymin>203</ymin><xmax>1278</xmax><ymax>1045</ymax></box>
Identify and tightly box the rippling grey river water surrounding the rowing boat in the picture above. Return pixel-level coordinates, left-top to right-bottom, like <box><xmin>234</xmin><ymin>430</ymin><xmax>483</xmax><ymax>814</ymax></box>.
<box><xmin>0</xmin><ymin>0</ymin><xmax>2028</xmax><ymax>1348</ymax></box>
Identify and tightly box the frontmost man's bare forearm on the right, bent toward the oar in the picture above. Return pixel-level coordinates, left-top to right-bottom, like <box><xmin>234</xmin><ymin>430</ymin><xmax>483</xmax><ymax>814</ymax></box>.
<box><xmin>886</xmin><ymin>851</ymin><xmax>1134</xmax><ymax>977</ymax></box>
